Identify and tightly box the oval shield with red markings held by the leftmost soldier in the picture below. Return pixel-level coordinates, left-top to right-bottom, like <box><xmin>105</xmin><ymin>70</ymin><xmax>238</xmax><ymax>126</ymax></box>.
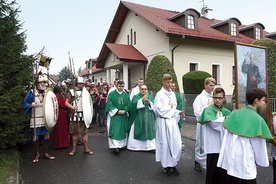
<box><xmin>43</xmin><ymin>88</ymin><xmax>58</xmax><ymax>131</ymax></box>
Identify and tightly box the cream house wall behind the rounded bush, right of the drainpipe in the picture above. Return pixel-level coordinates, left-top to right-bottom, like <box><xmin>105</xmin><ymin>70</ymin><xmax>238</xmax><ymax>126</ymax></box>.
<box><xmin>171</xmin><ymin>39</ymin><xmax>234</xmax><ymax>95</ymax></box>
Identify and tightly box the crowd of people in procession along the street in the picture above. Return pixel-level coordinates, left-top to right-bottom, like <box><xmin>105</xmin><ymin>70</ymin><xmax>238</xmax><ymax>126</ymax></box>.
<box><xmin>23</xmin><ymin>74</ymin><xmax>276</xmax><ymax>184</ymax></box>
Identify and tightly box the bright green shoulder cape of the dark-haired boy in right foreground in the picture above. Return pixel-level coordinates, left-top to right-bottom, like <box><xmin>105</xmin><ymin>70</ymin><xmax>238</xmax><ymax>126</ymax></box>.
<box><xmin>222</xmin><ymin>106</ymin><xmax>272</xmax><ymax>140</ymax></box>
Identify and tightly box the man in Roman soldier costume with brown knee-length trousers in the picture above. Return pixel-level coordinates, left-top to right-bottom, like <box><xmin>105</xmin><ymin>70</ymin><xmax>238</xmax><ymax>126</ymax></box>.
<box><xmin>69</xmin><ymin>77</ymin><xmax>93</xmax><ymax>156</ymax></box>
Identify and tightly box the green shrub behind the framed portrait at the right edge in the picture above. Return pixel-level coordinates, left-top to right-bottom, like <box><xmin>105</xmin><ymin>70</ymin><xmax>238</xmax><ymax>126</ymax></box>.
<box><xmin>253</xmin><ymin>39</ymin><xmax>276</xmax><ymax>98</ymax></box>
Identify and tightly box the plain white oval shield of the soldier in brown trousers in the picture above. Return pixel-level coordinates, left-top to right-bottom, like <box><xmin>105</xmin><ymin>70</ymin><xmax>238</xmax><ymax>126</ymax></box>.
<box><xmin>82</xmin><ymin>87</ymin><xmax>93</xmax><ymax>128</ymax></box>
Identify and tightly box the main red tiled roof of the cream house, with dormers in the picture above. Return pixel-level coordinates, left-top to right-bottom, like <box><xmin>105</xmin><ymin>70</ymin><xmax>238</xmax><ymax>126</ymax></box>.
<box><xmin>96</xmin><ymin>1</ymin><xmax>266</xmax><ymax>68</ymax></box>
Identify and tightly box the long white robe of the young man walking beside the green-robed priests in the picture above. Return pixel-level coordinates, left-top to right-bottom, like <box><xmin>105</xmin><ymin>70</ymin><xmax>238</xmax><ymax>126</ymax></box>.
<box><xmin>153</xmin><ymin>87</ymin><xmax>182</xmax><ymax>168</ymax></box>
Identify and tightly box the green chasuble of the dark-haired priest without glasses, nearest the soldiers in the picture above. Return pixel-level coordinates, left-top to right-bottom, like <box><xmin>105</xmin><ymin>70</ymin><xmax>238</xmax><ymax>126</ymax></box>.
<box><xmin>105</xmin><ymin>90</ymin><xmax>130</xmax><ymax>140</ymax></box>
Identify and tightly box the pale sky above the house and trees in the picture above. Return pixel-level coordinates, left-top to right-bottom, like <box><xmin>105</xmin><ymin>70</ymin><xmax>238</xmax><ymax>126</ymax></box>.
<box><xmin>16</xmin><ymin>0</ymin><xmax>276</xmax><ymax>74</ymax></box>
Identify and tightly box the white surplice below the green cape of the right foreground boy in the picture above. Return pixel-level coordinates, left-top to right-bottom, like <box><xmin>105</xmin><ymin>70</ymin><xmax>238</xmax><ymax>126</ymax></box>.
<box><xmin>217</xmin><ymin>129</ymin><xmax>269</xmax><ymax>180</ymax></box>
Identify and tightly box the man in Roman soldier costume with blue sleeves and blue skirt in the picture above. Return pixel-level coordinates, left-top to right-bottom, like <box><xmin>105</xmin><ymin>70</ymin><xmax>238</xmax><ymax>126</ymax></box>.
<box><xmin>23</xmin><ymin>72</ymin><xmax>55</xmax><ymax>163</ymax></box>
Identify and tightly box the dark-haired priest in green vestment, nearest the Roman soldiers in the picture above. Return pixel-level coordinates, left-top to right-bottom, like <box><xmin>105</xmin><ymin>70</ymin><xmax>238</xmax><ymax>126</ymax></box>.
<box><xmin>105</xmin><ymin>81</ymin><xmax>131</xmax><ymax>153</ymax></box>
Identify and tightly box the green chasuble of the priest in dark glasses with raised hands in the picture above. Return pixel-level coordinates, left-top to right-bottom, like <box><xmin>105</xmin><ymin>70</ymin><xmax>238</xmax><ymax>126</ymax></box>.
<box><xmin>130</xmin><ymin>93</ymin><xmax>156</xmax><ymax>141</ymax></box>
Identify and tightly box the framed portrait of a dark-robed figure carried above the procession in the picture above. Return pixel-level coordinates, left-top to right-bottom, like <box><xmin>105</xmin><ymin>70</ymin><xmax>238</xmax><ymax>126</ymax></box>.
<box><xmin>235</xmin><ymin>43</ymin><xmax>268</xmax><ymax>108</ymax></box>
